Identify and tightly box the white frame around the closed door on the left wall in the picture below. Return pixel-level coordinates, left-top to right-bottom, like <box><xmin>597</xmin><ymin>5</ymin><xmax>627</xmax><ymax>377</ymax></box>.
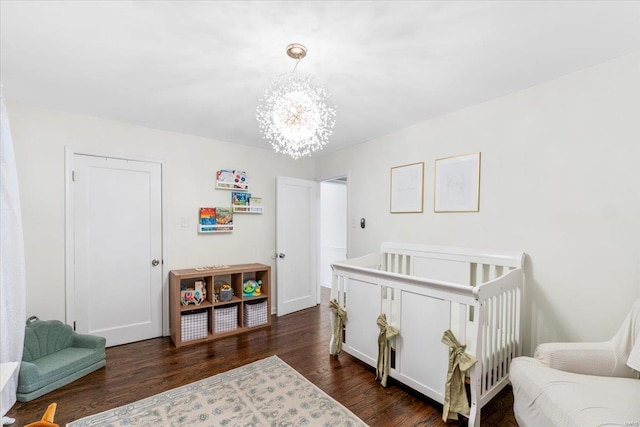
<box><xmin>64</xmin><ymin>146</ymin><xmax>169</xmax><ymax>336</ymax></box>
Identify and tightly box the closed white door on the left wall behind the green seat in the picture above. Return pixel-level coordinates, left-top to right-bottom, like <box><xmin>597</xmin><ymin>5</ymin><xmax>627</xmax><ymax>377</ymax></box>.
<box><xmin>68</xmin><ymin>154</ymin><xmax>163</xmax><ymax>346</ymax></box>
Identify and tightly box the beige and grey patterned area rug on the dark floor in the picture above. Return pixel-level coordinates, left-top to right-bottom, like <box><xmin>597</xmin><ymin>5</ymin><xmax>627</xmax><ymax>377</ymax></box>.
<box><xmin>67</xmin><ymin>356</ymin><xmax>366</xmax><ymax>427</ymax></box>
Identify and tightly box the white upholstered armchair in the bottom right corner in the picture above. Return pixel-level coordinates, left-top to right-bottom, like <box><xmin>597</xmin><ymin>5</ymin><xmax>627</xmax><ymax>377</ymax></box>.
<box><xmin>509</xmin><ymin>299</ymin><xmax>640</xmax><ymax>427</ymax></box>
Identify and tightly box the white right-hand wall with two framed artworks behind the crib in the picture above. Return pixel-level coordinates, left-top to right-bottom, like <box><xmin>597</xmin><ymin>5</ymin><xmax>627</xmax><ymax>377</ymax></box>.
<box><xmin>316</xmin><ymin>53</ymin><xmax>640</xmax><ymax>354</ymax></box>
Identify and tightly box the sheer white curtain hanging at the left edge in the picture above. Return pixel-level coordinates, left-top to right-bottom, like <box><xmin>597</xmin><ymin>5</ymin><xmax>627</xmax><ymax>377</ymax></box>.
<box><xmin>0</xmin><ymin>97</ymin><xmax>26</xmax><ymax>417</ymax></box>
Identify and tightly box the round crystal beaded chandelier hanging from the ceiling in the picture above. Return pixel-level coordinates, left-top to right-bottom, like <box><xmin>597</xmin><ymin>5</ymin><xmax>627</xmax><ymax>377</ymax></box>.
<box><xmin>256</xmin><ymin>43</ymin><xmax>336</xmax><ymax>159</ymax></box>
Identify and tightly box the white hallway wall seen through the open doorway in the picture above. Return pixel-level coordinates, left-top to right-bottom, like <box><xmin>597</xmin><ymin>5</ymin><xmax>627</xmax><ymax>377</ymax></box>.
<box><xmin>320</xmin><ymin>181</ymin><xmax>347</xmax><ymax>288</ymax></box>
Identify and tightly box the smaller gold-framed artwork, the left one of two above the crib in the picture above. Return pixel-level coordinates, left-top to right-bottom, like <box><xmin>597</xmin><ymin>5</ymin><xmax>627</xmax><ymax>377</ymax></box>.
<box><xmin>390</xmin><ymin>162</ymin><xmax>424</xmax><ymax>213</ymax></box>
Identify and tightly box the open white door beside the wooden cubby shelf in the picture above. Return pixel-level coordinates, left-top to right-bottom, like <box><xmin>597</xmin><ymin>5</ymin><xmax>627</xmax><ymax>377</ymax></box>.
<box><xmin>276</xmin><ymin>176</ymin><xmax>318</xmax><ymax>316</ymax></box>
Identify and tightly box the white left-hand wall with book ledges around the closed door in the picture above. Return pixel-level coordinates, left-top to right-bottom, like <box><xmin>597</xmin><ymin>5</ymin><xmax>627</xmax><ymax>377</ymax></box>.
<box><xmin>7</xmin><ymin>102</ymin><xmax>314</xmax><ymax>320</ymax></box>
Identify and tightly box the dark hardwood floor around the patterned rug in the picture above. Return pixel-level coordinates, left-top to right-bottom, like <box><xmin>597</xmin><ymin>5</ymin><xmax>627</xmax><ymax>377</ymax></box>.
<box><xmin>7</xmin><ymin>290</ymin><xmax>517</xmax><ymax>427</ymax></box>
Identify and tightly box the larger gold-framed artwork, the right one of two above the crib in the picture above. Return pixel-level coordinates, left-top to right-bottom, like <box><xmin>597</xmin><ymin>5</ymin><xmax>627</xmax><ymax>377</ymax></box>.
<box><xmin>433</xmin><ymin>152</ymin><xmax>480</xmax><ymax>212</ymax></box>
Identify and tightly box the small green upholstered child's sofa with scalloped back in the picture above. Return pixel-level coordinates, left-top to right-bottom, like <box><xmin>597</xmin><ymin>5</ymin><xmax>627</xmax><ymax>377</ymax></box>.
<box><xmin>17</xmin><ymin>316</ymin><xmax>106</xmax><ymax>402</ymax></box>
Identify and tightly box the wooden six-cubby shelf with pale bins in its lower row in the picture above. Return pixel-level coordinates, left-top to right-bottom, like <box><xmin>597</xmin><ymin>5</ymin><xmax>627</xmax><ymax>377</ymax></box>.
<box><xmin>169</xmin><ymin>264</ymin><xmax>271</xmax><ymax>347</ymax></box>
